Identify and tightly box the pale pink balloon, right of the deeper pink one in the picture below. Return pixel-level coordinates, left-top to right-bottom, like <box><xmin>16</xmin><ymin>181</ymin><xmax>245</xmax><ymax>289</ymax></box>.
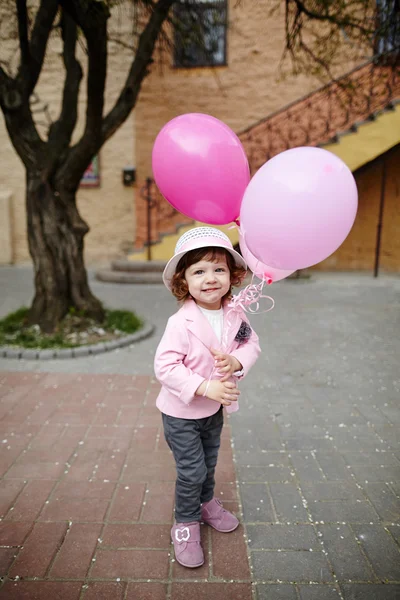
<box><xmin>240</xmin><ymin>147</ymin><xmax>357</xmax><ymax>270</ymax></box>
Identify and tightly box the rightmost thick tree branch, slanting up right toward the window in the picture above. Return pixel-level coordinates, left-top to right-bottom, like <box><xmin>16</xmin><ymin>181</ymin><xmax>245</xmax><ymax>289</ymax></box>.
<box><xmin>101</xmin><ymin>0</ymin><xmax>176</xmax><ymax>143</ymax></box>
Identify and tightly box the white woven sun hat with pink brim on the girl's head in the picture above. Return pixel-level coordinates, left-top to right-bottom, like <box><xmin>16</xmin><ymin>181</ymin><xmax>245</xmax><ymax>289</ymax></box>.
<box><xmin>163</xmin><ymin>227</ymin><xmax>247</xmax><ymax>290</ymax></box>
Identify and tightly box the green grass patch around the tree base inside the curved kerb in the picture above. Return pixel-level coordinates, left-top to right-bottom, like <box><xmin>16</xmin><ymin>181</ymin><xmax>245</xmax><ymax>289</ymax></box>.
<box><xmin>0</xmin><ymin>307</ymin><xmax>143</xmax><ymax>349</ymax></box>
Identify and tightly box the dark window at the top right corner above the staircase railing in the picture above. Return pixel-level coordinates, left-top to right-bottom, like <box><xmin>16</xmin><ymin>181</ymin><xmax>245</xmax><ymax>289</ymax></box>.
<box><xmin>376</xmin><ymin>0</ymin><xmax>400</xmax><ymax>55</ymax></box>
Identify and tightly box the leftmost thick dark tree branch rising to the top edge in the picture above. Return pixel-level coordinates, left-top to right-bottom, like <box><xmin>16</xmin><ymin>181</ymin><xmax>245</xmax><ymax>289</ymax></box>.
<box><xmin>17</xmin><ymin>0</ymin><xmax>58</xmax><ymax>98</ymax></box>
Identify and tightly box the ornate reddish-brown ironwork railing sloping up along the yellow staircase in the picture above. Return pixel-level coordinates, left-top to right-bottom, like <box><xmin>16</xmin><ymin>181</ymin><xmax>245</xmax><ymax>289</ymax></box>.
<box><xmin>238</xmin><ymin>59</ymin><xmax>400</xmax><ymax>173</ymax></box>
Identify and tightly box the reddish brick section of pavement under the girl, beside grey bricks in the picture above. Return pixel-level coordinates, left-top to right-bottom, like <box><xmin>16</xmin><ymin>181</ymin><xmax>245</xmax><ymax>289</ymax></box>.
<box><xmin>0</xmin><ymin>373</ymin><xmax>252</xmax><ymax>600</ymax></box>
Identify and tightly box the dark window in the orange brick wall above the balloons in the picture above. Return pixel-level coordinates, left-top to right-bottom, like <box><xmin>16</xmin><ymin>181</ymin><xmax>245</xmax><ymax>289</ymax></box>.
<box><xmin>174</xmin><ymin>0</ymin><xmax>227</xmax><ymax>67</ymax></box>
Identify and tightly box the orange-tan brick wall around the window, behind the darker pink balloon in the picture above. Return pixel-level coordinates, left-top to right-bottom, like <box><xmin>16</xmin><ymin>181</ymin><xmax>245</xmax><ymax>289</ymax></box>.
<box><xmin>135</xmin><ymin>0</ymin><xmax>360</xmax><ymax>249</ymax></box>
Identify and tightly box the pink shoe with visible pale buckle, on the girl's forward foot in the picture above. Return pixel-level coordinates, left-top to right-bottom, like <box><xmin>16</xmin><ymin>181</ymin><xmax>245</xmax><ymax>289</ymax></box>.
<box><xmin>171</xmin><ymin>521</ymin><xmax>204</xmax><ymax>569</ymax></box>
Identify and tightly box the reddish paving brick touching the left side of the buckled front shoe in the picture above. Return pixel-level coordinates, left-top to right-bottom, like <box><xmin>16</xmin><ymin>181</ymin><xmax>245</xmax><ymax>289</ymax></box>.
<box><xmin>102</xmin><ymin>523</ymin><xmax>171</xmax><ymax>548</ymax></box>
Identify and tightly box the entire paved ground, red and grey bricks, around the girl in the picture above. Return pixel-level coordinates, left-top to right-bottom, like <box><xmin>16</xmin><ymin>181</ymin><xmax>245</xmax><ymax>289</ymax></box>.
<box><xmin>0</xmin><ymin>269</ymin><xmax>400</xmax><ymax>600</ymax></box>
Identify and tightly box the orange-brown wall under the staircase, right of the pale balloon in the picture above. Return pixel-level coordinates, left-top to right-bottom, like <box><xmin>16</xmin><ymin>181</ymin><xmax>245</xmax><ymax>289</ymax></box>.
<box><xmin>313</xmin><ymin>145</ymin><xmax>400</xmax><ymax>273</ymax></box>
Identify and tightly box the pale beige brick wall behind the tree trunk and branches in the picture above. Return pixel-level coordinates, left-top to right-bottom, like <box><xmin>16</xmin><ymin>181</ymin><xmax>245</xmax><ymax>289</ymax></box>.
<box><xmin>0</xmin><ymin>7</ymin><xmax>135</xmax><ymax>264</ymax></box>
